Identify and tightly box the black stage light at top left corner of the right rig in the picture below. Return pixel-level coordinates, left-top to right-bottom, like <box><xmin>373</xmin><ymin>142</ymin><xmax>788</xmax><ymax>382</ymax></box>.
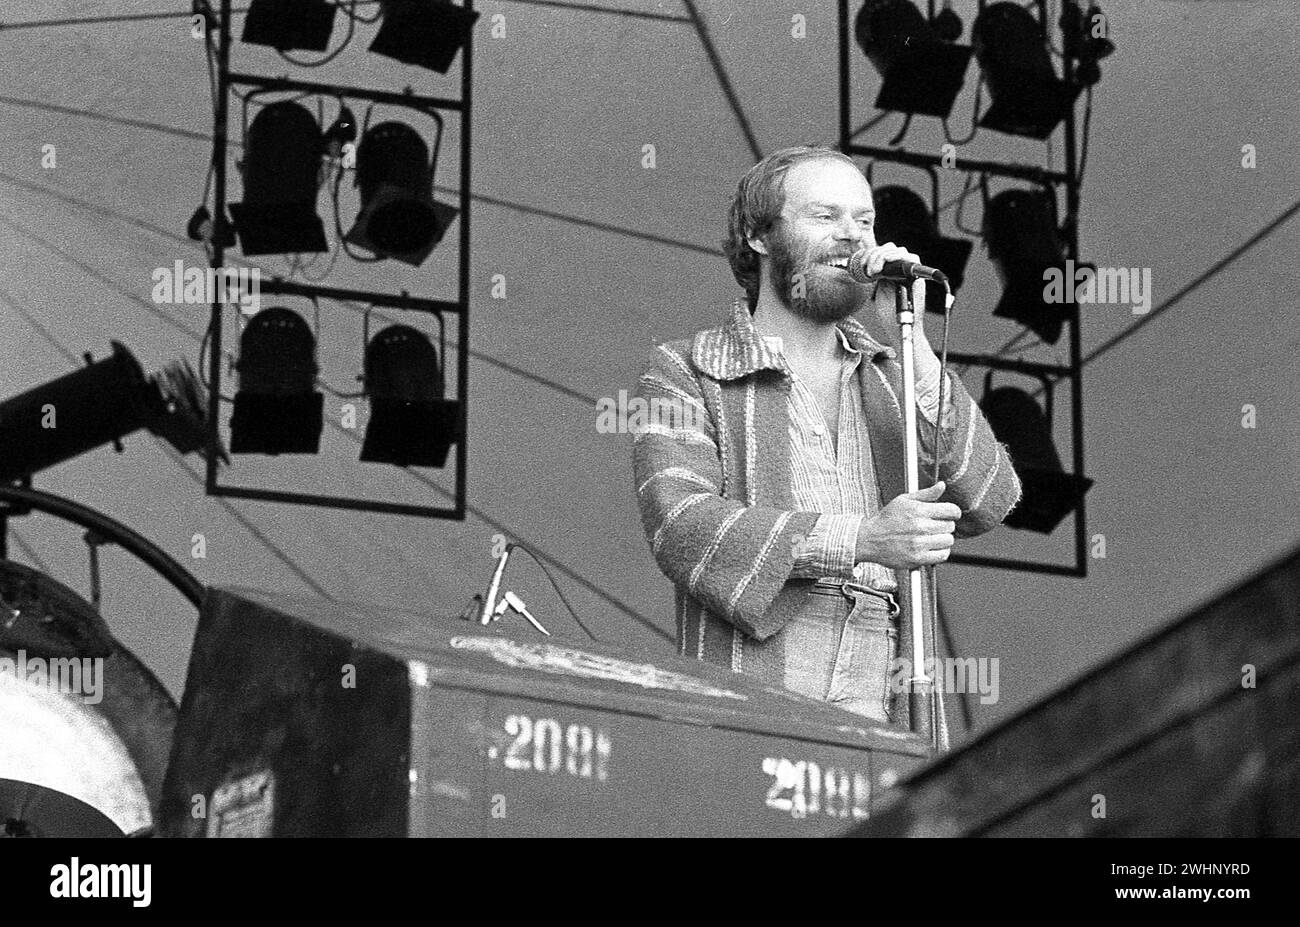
<box><xmin>854</xmin><ymin>0</ymin><xmax>971</xmax><ymax>118</ymax></box>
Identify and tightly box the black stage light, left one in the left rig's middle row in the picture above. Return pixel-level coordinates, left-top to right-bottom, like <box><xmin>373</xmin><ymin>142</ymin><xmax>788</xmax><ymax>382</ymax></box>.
<box><xmin>230</xmin><ymin>100</ymin><xmax>329</xmax><ymax>255</ymax></box>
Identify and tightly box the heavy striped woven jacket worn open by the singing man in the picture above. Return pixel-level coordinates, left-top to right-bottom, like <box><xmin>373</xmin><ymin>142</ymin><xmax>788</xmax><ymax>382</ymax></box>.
<box><xmin>629</xmin><ymin>300</ymin><xmax>1021</xmax><ymax>740</ymax></box>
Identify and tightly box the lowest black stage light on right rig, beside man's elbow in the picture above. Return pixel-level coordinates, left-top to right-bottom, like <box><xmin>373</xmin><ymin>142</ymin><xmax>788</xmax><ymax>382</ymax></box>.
<box><xmin>980</xmin><ymin>386</ymin><xmax>1092</xmax><ymax>534</ymax></box>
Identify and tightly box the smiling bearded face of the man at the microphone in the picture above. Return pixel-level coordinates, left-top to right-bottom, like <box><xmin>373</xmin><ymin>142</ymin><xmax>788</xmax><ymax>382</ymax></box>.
<box><xmin>764</xmin><ymin>159</ymin><xmax>876</xmax><ymax>322</ymax></box>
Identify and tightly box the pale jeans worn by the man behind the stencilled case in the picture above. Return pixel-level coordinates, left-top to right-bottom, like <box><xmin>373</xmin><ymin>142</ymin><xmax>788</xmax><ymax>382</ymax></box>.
<box><xmin>781</xmin><ymin>581</ymin><xmax>898</xmax><ymax>724</ymax></box>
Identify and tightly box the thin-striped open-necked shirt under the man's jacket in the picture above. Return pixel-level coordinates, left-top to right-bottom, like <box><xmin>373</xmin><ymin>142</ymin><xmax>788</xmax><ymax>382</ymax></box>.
<box><xmin>762</xmin><ymin>328</ymin><xmax>939</xmax><ymax>592</ymax></box>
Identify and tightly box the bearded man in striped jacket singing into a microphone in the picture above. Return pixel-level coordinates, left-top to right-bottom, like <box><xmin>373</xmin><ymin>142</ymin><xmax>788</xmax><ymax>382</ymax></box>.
<box><xmin>633</xmin><ymin>147</ymin><xmax>1021</xmax><ymax>749</ymax></box>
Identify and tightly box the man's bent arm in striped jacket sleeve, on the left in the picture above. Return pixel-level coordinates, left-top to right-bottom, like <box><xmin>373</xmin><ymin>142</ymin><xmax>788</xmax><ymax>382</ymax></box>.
<box><xmin>632</xmin><ymin>345</ymin><xmax>818</xmax><ymax>640</ymax></box>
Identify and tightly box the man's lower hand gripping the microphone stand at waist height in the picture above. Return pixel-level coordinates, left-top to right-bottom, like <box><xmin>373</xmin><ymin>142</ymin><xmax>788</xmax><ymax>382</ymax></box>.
<box><xmin>855</xmin><ymin>480</ymin><xmax>962</xmax><ymax>569</ymax></box>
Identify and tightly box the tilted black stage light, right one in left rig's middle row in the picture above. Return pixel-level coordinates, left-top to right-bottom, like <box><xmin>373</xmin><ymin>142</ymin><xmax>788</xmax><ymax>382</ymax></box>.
<box><xmin>345</xmin><ymin>122</ymin><xmax>458</xmax><ymax>267</ymax></box>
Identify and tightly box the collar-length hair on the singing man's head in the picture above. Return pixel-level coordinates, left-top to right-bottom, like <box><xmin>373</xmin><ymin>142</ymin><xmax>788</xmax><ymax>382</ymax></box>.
<box><xmin>723</xmin><ymin>144</ymin><xmax>858</xmax><ymax>312</ymax></box>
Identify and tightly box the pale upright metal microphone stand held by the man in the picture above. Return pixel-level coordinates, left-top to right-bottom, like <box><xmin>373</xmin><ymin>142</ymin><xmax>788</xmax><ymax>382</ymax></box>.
<box><xmin>894</xmin><ymin>281</ymin><xmax>943</xmax><ymax>751</ymax></box>
